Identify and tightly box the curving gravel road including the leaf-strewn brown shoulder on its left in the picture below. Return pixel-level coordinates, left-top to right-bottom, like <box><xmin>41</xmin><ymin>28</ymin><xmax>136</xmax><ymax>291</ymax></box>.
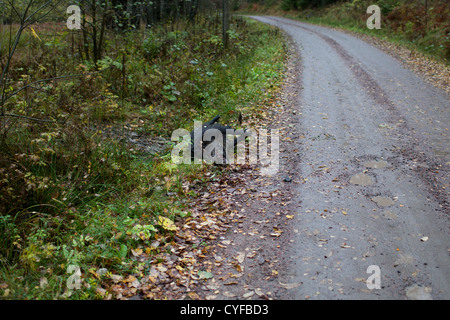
<box><xmin>204</xmin><ymin>17</ymin><xmax>450</xmax><ymax>299</ymax></box>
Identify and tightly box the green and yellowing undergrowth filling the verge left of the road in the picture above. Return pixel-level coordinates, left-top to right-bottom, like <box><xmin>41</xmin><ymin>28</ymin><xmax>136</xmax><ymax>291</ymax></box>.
<box><xmin>0</xmin><ymin>1</ymin><xmax>285</xmax><ymax>299</ymax></box>
